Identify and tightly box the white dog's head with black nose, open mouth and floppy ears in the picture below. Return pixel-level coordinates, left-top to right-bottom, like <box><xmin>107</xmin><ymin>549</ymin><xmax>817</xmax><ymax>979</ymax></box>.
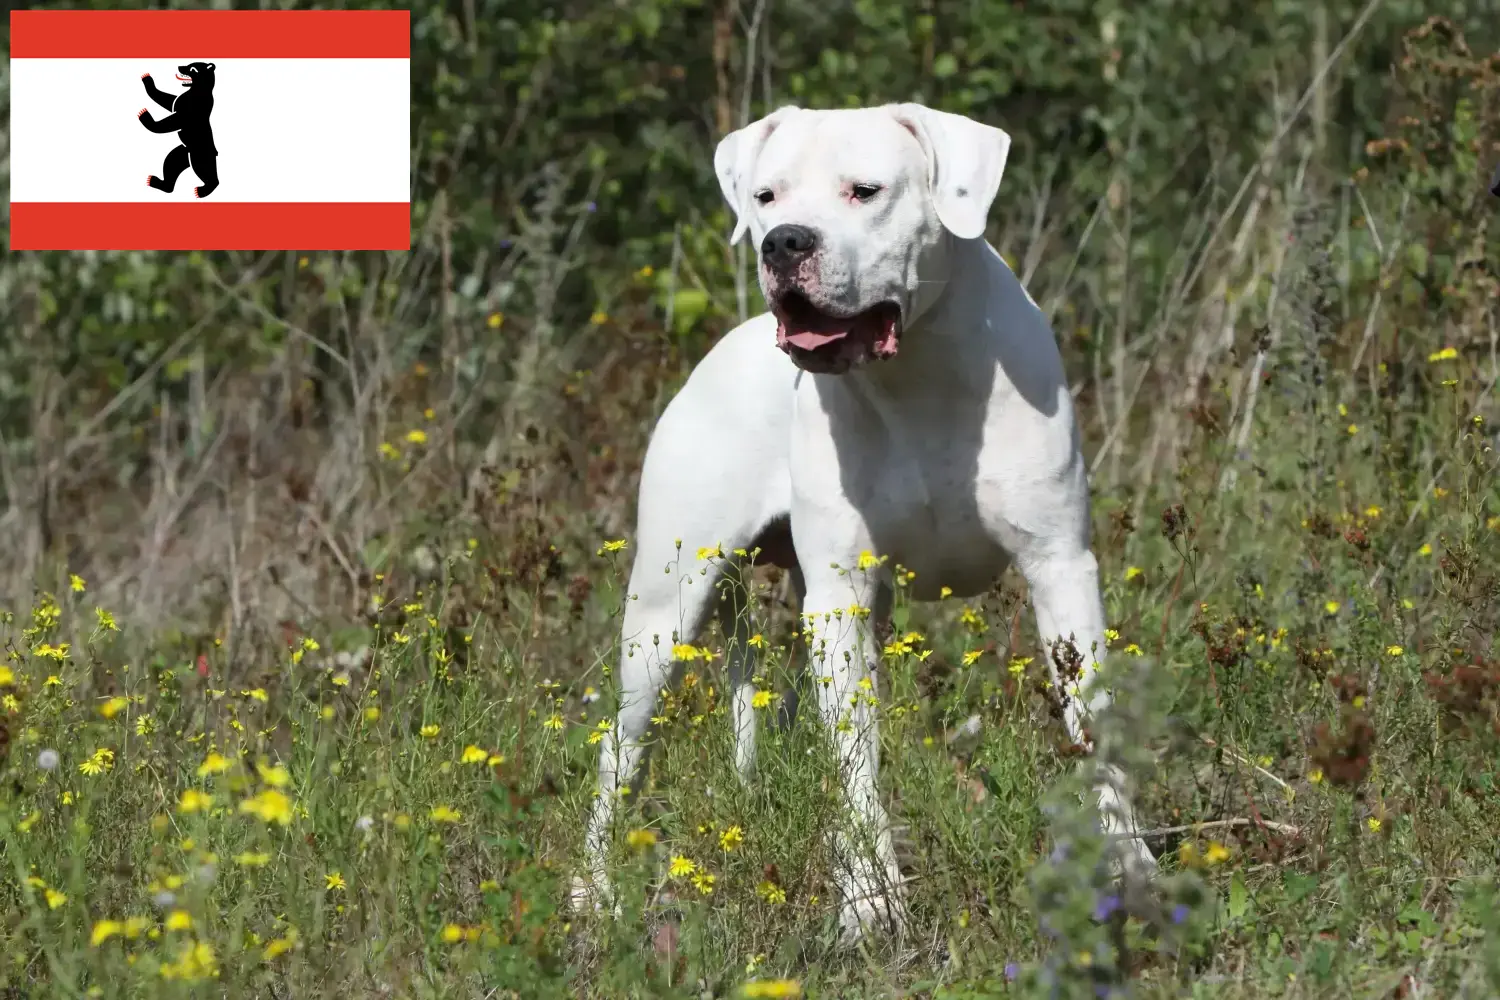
<box><xmin>714</xmin><ymin>103</ymin><xmax>1011</xmax><ymax>373</ymax></box>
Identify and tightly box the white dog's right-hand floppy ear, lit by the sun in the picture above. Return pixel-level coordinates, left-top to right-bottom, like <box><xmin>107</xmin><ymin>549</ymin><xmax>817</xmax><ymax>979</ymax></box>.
<box><xmin>891</xmin><ymin>103</ymin><xmax>1011</xmax><ymax>240</ymax></box>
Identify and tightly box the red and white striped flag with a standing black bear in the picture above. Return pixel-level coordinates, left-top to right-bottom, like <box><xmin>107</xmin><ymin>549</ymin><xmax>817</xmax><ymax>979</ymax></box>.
<box><xmin>11</xmin><ymin>10</ymin><xmax>411</xmax><ymax>250</ymax></box>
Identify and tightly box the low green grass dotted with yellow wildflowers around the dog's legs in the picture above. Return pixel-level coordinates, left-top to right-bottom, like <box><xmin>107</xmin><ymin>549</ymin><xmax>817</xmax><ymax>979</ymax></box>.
<box><xmin>0</xmin><ymin>371</ymin><xmax>1500</xmax><ymax>997</ymax></box>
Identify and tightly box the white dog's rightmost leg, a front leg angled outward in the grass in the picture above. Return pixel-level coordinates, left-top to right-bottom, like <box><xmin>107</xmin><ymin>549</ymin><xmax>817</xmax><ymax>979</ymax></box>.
<box><xmin>1020</xmin><ymin>546</ymin><xmax>1157</xmax><ymax>876</ymax></box>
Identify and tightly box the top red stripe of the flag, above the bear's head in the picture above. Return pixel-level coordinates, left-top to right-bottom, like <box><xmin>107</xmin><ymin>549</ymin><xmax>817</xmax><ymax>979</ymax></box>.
<box><xmin>11</xmin><ymin>10</ymin><xmax>411</xmax><ymax>60</ymax></box>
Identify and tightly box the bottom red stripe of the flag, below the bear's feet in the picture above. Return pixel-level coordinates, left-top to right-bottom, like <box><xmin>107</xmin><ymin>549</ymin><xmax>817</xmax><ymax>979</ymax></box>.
<box><xmin>11</xmin><ymin>201</ymin><xmax>411</xmax><ymax>250</ymax></box>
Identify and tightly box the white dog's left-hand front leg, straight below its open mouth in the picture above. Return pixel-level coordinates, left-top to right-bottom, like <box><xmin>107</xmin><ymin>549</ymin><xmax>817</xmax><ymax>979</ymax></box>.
<box><xmin>803</xmin><ymin>570</ymin><xmax>906</xmax><ymax>942</ymax></box>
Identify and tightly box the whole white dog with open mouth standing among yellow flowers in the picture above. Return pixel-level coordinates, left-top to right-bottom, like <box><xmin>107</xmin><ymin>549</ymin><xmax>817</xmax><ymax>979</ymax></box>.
<box><xmin>575</xmin><ymin>103</ymin><xmax>1155</xmax><ymax>934</ymax></box>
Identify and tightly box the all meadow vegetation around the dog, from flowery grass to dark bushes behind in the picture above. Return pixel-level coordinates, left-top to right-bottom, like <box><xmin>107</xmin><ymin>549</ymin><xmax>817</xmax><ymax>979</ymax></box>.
<box><xmin>0</xmin><ymin>0</ymin><xmax>1500</xmax><ymax>1000</ymax></box>
